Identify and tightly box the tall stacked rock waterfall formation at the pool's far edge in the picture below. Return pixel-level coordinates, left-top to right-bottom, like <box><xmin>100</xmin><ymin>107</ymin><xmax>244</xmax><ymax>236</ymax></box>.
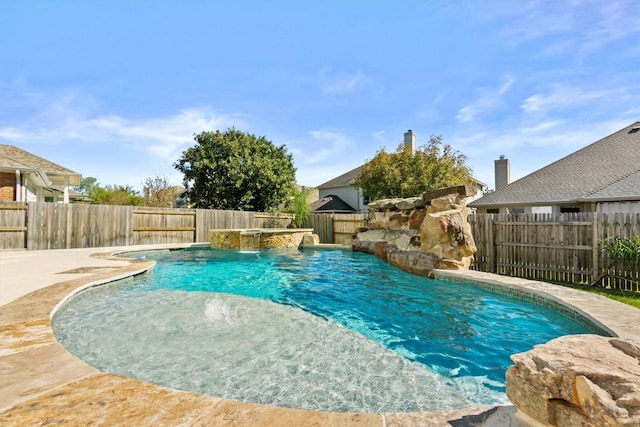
<box><xmin>353</xmin><ymin>186</ymin><xmax>476</xmax><ymax>276</ymax></box>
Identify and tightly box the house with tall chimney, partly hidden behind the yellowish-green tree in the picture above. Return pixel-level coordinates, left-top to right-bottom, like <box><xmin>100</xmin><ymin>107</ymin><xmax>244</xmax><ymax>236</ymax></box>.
<box><xmin>312</xmin><ymin>129</ymin><xmax>486</xmax><ymax>213</ymax></box>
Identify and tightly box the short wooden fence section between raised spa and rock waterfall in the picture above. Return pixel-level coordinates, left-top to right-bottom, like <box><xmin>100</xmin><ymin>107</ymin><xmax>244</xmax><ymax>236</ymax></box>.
<box><xmin>302</xmin><ymin>214</ymin><xmax>366</xmax><ymax>245</ymax></box>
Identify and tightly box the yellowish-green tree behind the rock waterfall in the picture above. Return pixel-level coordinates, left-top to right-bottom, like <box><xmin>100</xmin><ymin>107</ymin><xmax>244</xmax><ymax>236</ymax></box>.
<box><xmin>355</xmin><ymin>135</ymin><xmax>471</xmax><ymax>200</ymax></box>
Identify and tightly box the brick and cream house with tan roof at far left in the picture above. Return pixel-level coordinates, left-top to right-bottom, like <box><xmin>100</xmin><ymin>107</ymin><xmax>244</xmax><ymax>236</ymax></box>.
<box><xmin>0</xmin><ymin>145</ymin><xmax>83</xmax><ymax>203</ymax></box>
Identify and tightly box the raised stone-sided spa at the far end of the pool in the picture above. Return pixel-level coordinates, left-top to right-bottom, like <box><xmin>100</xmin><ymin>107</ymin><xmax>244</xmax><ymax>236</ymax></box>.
<box><xmin>210</xmin><ymin>228</ymin><xmax>313</xmax><ymax>250</ymax></box>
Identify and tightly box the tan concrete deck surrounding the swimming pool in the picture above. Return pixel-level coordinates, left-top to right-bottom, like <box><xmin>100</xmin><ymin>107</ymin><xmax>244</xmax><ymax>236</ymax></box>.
<box><xmin>0</xmin><ymin>245</ymin><xmax>640</xmax><ymax>427</ymax></box>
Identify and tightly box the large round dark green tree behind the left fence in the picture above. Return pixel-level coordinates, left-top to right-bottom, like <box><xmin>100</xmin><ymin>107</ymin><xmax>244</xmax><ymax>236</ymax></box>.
<box><xmin>174</xmin><ymin>129</ymin><xmax>295</xmax><ymax>211</ymax></box>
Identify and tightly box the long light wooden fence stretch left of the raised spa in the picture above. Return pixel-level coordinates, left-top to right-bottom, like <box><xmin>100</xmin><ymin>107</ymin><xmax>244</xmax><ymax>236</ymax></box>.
<box><xmin>0</xmin><ymin>203</ymin><xmax>293</xmax><ymax>250</ymax></box>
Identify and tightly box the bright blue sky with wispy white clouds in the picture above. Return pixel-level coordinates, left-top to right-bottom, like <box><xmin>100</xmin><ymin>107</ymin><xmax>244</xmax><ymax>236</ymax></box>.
<box><xmin>0</xmin><ymin>0</ymin><xmax>640</xmax><ymax>188</ymax></box>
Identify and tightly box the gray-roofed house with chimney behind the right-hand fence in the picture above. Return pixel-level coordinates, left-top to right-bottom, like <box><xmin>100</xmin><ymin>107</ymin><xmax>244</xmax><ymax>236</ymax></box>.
<box><xmin>470</xmin><ymin>122</ymin><xmax>640</xmax><ymax>213</ymax></box>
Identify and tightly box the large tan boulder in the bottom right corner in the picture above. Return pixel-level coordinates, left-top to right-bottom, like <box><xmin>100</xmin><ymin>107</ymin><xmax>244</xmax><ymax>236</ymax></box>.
<box><xmin>506</xmin><ymin>335</ymin><xmax>640</xmax><ymax>427</ymax></box>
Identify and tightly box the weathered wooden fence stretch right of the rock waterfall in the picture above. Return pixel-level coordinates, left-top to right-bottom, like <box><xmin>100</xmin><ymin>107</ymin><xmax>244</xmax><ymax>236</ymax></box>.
<box><xmin>469</xmin><ymin>213</ymin><xmax>640</xmax><ymax>292</ymax></box>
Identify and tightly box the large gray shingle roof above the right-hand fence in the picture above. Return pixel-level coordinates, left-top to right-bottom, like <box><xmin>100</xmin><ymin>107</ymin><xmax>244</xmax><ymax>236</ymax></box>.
<box><xmin>469</xmin><ymin>122</ymin><xmax>640</xmax><ymax>207</ymax></box>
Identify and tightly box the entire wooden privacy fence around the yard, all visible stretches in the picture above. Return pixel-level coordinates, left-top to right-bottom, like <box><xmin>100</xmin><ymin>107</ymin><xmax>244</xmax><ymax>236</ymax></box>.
<box><xmin>0</xmin><ymin>203</ymin><xmax>640</xmax><ymax>292</ymax></box>
